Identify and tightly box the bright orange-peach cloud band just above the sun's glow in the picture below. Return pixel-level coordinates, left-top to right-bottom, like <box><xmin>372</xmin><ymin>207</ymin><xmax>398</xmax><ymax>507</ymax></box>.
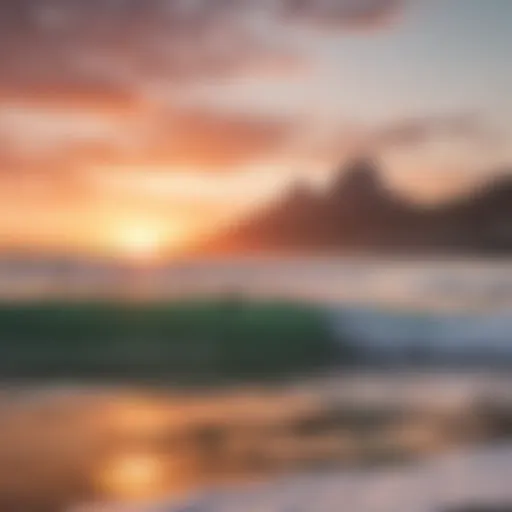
<box><xmin>0</xmin><ymin>103</ymin><xmax>297</xmax><ymax>175</ymax></box>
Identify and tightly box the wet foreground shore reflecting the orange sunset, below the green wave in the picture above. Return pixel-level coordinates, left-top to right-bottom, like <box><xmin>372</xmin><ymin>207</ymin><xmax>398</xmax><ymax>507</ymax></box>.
<box><xmin>0</xmin><ymin>374</ymin><xmax>512</xmax><ymax>512</ymax></box>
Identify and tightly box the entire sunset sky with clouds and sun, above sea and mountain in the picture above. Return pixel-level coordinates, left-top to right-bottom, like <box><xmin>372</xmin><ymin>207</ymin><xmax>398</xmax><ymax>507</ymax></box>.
<box><xmin>0</xmin><ymin>0</ymin><xmax>512</xmax><ymax>255</ymax></box>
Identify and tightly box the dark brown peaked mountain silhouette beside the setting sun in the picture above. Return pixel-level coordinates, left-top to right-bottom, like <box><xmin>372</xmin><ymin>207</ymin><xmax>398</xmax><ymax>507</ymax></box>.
<box><xmin>196</xmin><ymin>158</ymin><xmax>512</xmax><ymax>253</ymax></box>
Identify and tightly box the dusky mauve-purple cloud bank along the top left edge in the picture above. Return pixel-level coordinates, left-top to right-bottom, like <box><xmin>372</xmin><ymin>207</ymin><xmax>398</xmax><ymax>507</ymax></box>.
<box><xmin>0</xmin><ymin>0</ymin><xmax>406</xmax><ymax>99</ymax></box>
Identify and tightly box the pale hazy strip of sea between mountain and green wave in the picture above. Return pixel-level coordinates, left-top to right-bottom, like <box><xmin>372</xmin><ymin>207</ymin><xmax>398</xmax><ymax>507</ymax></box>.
<box><xmin>0</xmin><ymin>255</ymin><xmax>512</xmax><ymax>312</ymax></box>
